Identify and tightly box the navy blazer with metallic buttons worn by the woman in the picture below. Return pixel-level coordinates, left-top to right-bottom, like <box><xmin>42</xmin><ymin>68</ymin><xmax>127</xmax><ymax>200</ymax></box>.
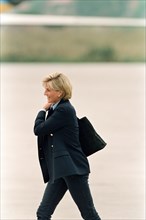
<box><xmin>34</xmin><ymin>100</ymin><xmax>90</xmax><ymax>183</ymax></box>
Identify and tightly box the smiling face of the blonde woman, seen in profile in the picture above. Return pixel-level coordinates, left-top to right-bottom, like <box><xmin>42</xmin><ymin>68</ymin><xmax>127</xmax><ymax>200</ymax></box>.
<box><xmin>44</xmin><ymin>88</ymin><xmax>62</xmax><ymax>104</ymax></box>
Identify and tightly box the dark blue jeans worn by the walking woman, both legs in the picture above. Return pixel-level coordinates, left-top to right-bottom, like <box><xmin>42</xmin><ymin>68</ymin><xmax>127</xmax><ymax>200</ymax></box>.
<box><xmin>37</xmin><ymin>175</ymin><xmax>101</xmax><ymax>220</ymax></box>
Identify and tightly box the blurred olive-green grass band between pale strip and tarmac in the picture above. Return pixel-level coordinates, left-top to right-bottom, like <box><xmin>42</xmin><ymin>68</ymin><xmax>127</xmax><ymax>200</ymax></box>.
<box><xmin>1</xmin><ymin>26</ymin><xmax>145</xmax><ymax>62</ymax></box>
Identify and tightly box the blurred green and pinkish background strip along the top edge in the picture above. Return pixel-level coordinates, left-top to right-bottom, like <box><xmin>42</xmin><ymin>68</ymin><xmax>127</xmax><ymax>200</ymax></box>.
<box><xmin>14</xmin><ymin>0</ymin><xmax>145</xmax><ymax>18</ymax></box>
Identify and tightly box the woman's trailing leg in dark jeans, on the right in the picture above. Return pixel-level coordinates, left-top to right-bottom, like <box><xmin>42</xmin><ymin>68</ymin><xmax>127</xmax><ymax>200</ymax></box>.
<box><xmin>64</xmin><ymin>175</ymin><xmax>101</xmax><ymax>220</ymax></box>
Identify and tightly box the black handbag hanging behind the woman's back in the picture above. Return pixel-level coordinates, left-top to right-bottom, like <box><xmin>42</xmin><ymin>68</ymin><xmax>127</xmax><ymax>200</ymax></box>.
<box><xmin>78</xmin><ymin>117</ymin><xmax>107</xmax><ymax>156</ymax></box>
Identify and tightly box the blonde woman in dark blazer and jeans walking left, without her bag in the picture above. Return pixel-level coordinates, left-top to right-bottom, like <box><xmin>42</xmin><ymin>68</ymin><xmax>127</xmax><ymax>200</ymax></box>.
<box><xmin>34</xmin><ymin>73</ymin><xmax>101</xmax><ymax>220</ymax></box>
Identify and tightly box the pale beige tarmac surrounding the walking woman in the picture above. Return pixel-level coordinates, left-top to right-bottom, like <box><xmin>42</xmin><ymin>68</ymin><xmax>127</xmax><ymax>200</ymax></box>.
<box><xmin>1</xmin><ymin>63</ymin><xmax>146</xmax><ymax>220</ymax></box>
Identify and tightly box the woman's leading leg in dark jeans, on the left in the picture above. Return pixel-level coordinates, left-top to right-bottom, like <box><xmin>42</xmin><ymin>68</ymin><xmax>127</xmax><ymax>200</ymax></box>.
<box><xmin>37</xmin><ymin>179</ymin><xmax>67</xmax><ymax>220</ymax></box>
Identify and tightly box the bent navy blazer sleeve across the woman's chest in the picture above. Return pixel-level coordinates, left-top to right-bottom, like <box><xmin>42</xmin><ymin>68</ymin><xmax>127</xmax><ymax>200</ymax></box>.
<box><xmin>34</xmin><ymin>107</ymin><xmax>70</xmax><ymax>136</ymax></box>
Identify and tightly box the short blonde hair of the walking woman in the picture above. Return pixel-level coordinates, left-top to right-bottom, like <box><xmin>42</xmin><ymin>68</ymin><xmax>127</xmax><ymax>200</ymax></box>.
<box><xmin>43</xmin><ymin>73</ymin><xmax>72</xmax><ymax>100</ymax></box>
